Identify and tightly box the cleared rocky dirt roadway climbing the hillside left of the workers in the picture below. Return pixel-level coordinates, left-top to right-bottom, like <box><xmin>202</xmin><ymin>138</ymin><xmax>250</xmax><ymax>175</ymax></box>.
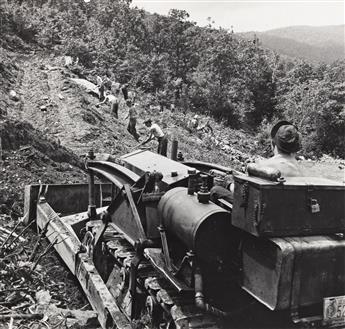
<box><xmin>8</xmin><ymin>54</ymin><xmax>135</xmax><ymax>155</ymax></box>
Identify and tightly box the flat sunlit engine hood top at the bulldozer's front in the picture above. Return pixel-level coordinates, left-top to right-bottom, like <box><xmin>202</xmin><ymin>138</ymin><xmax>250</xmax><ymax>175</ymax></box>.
<box><xmin>121</xmin><ymin>150</ymin><xmax>193</xmax><ymax>186</ymax></box>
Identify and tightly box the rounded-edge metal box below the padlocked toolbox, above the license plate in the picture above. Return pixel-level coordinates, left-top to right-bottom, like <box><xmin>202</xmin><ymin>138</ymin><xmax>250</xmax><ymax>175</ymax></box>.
<box><xmin>242</xmin><ymin>236</ymin><xmax>345</xmax><ymax>310</ymax></box>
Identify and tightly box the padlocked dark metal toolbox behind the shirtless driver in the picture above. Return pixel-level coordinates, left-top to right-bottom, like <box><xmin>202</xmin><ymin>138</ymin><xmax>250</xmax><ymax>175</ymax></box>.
<box><xmin>232</xmin><ymin>175</ymin><xmax>345</xmax><ymax>237</ymax></box>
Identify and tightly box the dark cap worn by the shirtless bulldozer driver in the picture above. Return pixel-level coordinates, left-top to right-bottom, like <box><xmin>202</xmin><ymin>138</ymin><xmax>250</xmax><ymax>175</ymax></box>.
<box><xmin>271</xmin><ymin>121</ymin><xmax>300</xmax><ymax>153</ymax></box>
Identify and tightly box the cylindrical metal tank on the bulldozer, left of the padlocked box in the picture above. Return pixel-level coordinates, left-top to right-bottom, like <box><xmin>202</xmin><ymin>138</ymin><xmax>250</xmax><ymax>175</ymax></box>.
<box><xmin>158</xmin><ymin>187</ymin><xmax>231</xmax><ymax>263</ymax></box>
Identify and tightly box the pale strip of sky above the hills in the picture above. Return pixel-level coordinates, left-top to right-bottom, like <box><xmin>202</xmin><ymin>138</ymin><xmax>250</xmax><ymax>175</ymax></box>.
<box><xmin>132</xmin><ymin>0</ymin><xmax>345</xmax><ymax>32</ymax></box>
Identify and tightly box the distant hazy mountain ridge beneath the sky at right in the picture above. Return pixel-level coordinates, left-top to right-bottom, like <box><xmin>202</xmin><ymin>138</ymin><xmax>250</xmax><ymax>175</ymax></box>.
<box><xmin>239</xmin><ymin>25</ymin><xmax>345</xmax><ymax>63</ymax></box>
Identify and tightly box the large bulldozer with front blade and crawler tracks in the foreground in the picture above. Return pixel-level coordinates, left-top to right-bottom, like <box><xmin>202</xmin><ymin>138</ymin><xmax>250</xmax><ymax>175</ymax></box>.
<box><xmin>25</xmin><ymin>150</ymin><xmax>345</xmax><ymax>329</ymax></box>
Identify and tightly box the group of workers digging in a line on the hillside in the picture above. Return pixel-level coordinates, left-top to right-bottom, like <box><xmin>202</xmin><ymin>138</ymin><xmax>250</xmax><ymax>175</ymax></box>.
<box><xmin>97</xmin><ymin>77</ymin><xmax>168</xmax><ymax>156</ymax></box>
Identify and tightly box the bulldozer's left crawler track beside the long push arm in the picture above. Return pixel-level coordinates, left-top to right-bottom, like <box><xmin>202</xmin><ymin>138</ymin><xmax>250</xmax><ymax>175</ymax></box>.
<box><xmin>99</xmin><ymin>227</ymin><xmax>221</xmax><ymax>329</ymax></box>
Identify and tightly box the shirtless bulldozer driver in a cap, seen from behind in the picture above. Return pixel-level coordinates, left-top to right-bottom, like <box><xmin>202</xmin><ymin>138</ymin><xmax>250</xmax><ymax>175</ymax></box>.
<box><xmin>210</xmin><ymin>121</ymin><xmax>303</xmax><ymax>203</ymax></box>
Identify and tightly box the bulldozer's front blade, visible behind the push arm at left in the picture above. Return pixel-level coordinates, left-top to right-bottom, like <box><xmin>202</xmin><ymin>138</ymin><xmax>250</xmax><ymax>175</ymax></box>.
<box><xmin>24</xmin><ymin>183</ymin><xmax>111</xmax><ymax>224</ymax></box>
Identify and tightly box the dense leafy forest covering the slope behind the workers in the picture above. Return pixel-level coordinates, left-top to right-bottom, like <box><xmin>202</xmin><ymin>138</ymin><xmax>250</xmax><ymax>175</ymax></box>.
<box><xmin>0</xmin><ymin>0</ymin><xmax>345</xmax><ymax>158</ymax></box>
